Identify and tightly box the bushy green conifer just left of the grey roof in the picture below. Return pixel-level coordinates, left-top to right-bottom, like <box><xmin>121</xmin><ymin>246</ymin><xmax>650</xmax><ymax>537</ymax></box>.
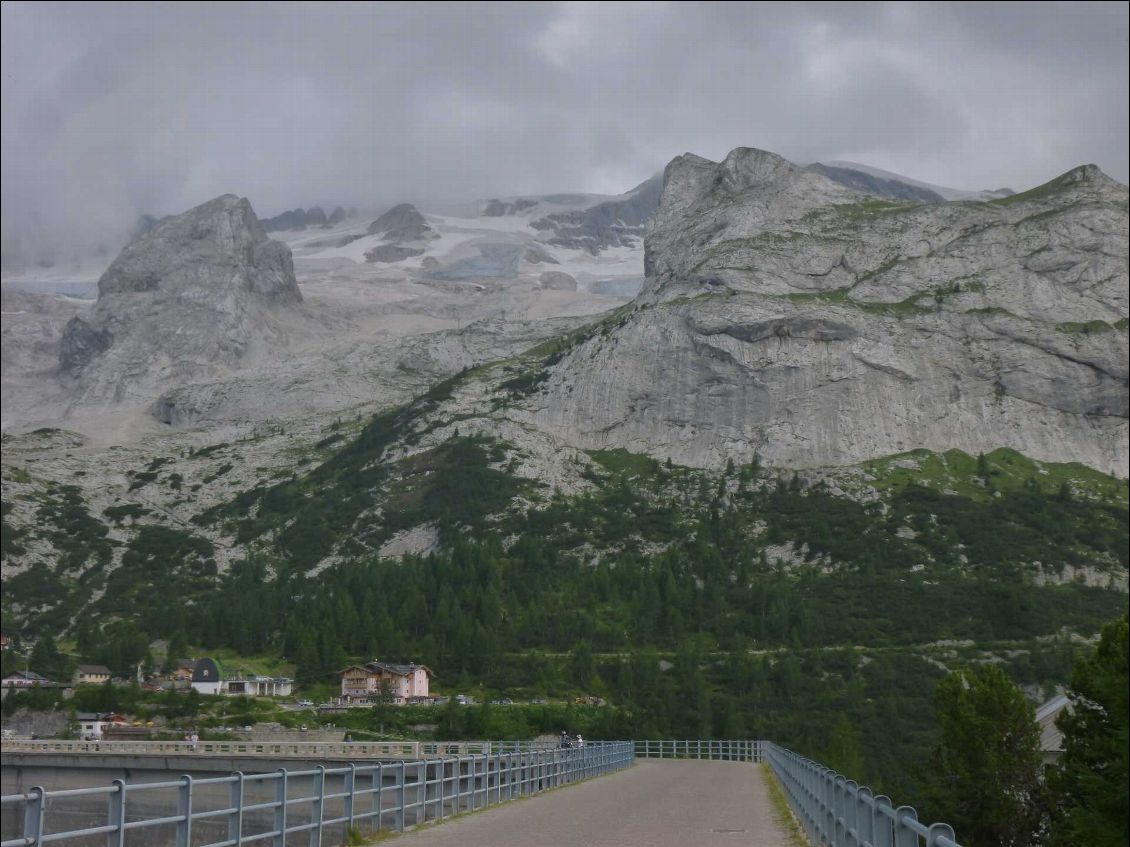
<box><xmin>923</xmin><ymin>665</ymin><xmax>1046</xmax><ymax>847</ymax></box>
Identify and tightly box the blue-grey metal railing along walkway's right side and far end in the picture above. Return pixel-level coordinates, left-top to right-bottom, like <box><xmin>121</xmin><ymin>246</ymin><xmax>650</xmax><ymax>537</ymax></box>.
<box><xmin>635</xmin><ymin>740</ymin><xmax>961</xmax><ymax>847</ymax></box>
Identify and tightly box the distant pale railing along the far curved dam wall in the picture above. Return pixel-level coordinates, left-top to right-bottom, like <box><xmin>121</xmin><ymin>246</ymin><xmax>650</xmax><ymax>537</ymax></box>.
<box><xmin>3</xmin><ymin>740</ymin><xmax>492</xmax><ymax>759</ymax></box>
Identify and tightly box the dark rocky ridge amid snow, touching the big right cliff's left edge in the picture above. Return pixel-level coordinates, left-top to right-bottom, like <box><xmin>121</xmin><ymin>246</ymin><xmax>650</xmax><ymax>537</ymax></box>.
<box><xmin>530</xmin><ymin>176</ymin><xmax>663</xmax><ymax>255</ymax></box>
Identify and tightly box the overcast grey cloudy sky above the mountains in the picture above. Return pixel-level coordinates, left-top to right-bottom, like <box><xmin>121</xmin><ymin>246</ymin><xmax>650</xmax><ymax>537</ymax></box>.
<box><xmin>2</xmin><ymin>2</ymin><xmax>1130</xmax><ymax>255</ymax></box>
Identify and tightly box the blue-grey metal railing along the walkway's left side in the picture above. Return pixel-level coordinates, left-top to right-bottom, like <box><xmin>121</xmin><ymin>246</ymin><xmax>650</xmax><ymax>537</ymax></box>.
<box><xmin>0</xmin><ymin>741</ymin><xmax>635</xmax><ymax>847</ymax></box>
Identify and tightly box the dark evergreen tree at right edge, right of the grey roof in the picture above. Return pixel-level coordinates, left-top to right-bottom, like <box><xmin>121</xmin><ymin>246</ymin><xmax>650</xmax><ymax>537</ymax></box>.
<box><xmin>1050</xmin><ymin>614</ymin><xmax>1130</xmax><ymax>847</ymax></box>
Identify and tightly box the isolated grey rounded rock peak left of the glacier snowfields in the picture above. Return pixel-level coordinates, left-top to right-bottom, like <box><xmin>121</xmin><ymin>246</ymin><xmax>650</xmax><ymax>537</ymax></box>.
<box><xmin>59</xmin><ymin>194</ymin><xmax>302</xmax><ymax>411</ymax></box>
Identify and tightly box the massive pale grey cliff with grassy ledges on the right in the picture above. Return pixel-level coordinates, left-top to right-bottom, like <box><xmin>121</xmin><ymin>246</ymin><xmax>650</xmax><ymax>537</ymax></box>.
<box><xmin>524</xmin><ymin>148</ymin><xmax>1130</xmax><ymax>475</ymax></box>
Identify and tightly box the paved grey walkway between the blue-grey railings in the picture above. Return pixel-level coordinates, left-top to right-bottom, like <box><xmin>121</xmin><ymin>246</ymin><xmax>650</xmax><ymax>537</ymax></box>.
<box><xmin>390</xmin><ymin>759</ymin><xmax>796</xmax><ymax>847</ymax></box>
